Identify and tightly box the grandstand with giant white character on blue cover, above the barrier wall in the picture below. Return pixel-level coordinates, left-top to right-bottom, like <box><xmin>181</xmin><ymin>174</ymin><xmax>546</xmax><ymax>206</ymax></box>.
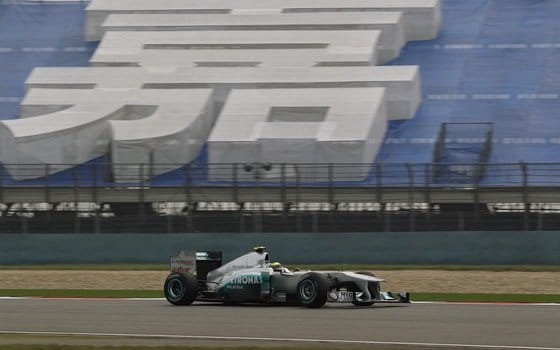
<box><xmin>0</xmin><ymin>0</ymin><xmax>560</xmax><ymax>232</ymax></box>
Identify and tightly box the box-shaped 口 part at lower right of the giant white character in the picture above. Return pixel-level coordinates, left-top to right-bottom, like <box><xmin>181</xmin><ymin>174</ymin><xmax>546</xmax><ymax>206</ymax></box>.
<box><xmin>208</xmin><ymin>88</ymin><xmax>387</xmax><ymax>181</ymax></box>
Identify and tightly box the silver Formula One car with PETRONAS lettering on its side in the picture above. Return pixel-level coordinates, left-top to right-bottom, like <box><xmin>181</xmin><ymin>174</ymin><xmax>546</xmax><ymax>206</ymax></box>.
<box><xmin>163</xmin><ymin>247</ymin><xmax>410</xmax><ymax>308</ymax></box>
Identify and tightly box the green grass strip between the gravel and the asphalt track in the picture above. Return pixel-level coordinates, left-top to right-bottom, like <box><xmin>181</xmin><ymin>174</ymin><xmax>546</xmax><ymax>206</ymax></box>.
<box><xmin>0</xmin><ymin>289</ymin><xmax>560</xmax><ymax>303</ymax></box>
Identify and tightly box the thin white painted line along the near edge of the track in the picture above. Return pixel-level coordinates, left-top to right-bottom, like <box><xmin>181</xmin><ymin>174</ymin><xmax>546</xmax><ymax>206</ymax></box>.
<box><xmin>0</xmin><ymin>331</ymin><xmax>560</xmax><ymax>350</ymax></box>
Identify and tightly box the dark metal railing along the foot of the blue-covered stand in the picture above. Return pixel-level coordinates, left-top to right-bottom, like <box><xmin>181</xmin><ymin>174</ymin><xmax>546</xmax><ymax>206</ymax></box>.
<box><xmin>0</xmin><ymin>162</ymin><xmax>560</xmax><ymax>189</ymax></box>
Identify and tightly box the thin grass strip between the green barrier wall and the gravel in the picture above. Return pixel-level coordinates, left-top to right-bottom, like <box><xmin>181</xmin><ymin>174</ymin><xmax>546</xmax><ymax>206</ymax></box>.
<box><xmin>0</xmin><ymin>263</ymin><xmax>560</xmax><ymax>272</ymax></box>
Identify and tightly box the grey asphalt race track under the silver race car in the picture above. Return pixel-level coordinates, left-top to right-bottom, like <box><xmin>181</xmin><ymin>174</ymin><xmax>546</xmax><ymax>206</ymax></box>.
<box><xmin>0</xmin><ymin>299</ymin><xmax>560</xmax><ymax>349</ymax></box>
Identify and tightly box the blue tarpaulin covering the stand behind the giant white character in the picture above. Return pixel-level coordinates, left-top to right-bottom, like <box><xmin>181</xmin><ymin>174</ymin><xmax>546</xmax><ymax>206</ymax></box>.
<box><xmin>0</xmin><ymin>0</ymin><xmax>560</xmax><ymax>185</ymax></box>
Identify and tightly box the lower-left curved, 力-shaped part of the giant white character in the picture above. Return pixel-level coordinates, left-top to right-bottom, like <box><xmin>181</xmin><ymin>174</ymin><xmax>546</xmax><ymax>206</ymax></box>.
<box><xmin>0</xmin><ymin>89</ymin><xmax>213</xmax><ymax>181</ymax></box>
